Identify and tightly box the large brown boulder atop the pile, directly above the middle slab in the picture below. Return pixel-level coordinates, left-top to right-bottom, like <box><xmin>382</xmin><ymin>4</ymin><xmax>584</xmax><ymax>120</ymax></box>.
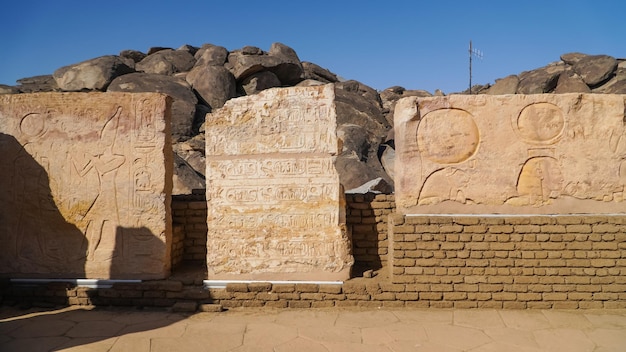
<box><xmin>226</xmin><ymin>43</ymin><xmax>304</xmax><ymax>85</ymax></box>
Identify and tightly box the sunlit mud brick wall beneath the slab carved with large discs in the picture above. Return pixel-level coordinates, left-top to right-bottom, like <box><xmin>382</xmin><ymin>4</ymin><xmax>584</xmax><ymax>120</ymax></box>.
<box><xmin>390</xmin><ymin>214</ymin><xmax>626</xmax><ymax>308</ymax></box>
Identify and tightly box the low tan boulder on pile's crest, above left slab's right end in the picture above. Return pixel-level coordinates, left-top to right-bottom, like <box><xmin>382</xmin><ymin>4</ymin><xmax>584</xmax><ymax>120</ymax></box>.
<box><xmin>135</xmin><ymin>49</ymin><xmax>196</xmax><ymax>75</ymax></box>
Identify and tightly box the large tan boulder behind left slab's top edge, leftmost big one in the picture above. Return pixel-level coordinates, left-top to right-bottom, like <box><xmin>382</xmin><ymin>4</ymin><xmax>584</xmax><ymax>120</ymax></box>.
<box><xmin>52</xmin><ymin>55</ymin><xmax>134</xmax><ymax>91</ymax></box>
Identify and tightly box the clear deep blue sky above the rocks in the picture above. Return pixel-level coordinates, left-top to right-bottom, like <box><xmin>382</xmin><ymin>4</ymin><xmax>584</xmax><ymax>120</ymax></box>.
<box><xmin>0</xmin><ymin>0</ymin><xmax>626</xmax><ymax>93</ymax></box>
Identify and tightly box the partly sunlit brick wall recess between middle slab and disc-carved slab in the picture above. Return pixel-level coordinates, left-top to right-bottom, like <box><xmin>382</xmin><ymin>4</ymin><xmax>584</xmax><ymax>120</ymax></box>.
<box><xmin>346</xmin><ymin>193</ymin><xmax>395</xmax><ymax>275</ymax></box>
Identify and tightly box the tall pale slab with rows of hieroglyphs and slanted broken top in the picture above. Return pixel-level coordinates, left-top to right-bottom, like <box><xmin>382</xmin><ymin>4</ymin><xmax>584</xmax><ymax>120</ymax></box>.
<box><xmin>205</xmin><ymin>85</ymin><xmax>353</xmax><ymax>280</ymax></box>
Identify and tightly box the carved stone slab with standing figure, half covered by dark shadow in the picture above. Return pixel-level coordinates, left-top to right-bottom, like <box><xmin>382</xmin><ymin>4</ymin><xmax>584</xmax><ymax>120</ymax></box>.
<box><xmin>0</xmin><ymin>93</ymin><xmax>172</xmax><ymax>279</ymax></box>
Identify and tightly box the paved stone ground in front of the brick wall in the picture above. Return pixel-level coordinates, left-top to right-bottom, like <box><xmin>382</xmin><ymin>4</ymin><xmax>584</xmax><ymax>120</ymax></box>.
<box><xmin>0</xmin><ymin>307</ymin><xmax>626</xmax><ymax>352</ymax></box>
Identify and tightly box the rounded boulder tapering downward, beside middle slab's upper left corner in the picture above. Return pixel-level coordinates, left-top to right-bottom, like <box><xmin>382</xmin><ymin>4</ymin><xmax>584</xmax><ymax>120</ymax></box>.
<box><xmin>187</xmin><ymin>65</ymin><xmax>237</xmax><ymax>109</ymax></box>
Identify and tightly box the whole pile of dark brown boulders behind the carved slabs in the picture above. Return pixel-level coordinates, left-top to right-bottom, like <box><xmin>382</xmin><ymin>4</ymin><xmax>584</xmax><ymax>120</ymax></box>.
<box><xmin>0</xmin><ymin>43</ymin><xmax>626</xmax><ymax>194</ymax></box>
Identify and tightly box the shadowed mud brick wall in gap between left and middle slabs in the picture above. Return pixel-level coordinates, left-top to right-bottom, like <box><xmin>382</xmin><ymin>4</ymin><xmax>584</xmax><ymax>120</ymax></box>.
<box><xmin>172</xmin><ymin>190</ymin><xmax>207</xmax><ymax>263</ymax></box>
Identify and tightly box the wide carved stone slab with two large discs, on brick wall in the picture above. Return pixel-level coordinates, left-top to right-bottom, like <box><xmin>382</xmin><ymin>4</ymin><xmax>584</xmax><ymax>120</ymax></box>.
<box><xmin>394</xmin><ymin>94</ymin><xmax>626</xmax><ymax>214</ymax></box>
